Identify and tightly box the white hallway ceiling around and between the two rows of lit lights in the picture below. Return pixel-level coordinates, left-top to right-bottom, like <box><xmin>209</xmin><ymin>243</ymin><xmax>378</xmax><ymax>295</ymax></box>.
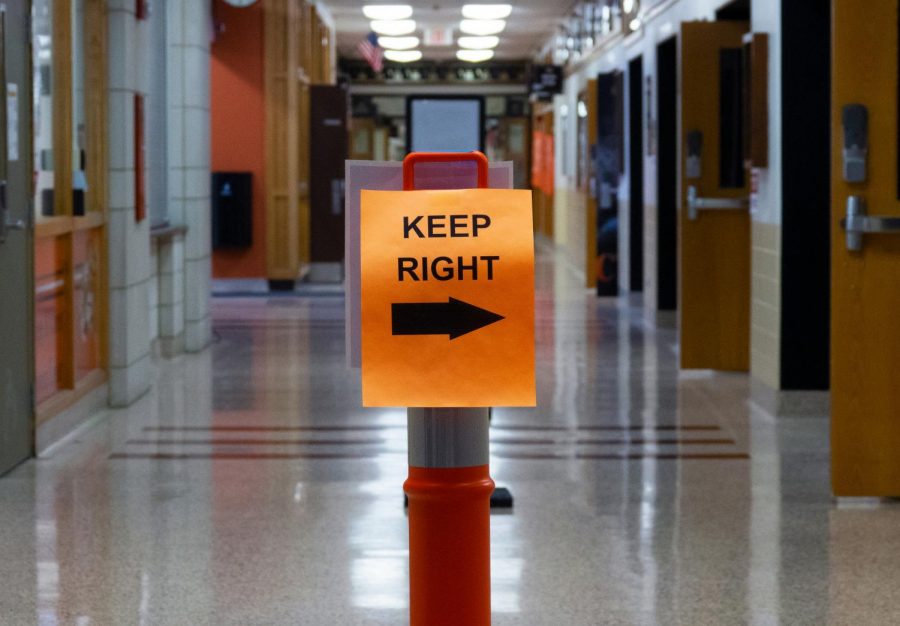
<box><xmin>323</xmin><ymin>0</ymin><xmax>575</xmax><ymax>61</ymax></box>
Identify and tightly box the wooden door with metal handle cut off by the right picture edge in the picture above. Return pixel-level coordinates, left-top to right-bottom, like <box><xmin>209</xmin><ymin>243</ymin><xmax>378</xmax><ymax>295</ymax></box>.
<box><xmin>831</xmin><ymin>0</ymin><xmax>900</xmax><ymax>497</ymax></box>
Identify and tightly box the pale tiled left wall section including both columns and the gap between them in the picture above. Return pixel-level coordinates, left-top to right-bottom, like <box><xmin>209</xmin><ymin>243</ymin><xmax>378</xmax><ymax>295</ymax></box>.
<box><xmin>108</xmin><ymin>0</ymin><xmax>211</xmax><ymax>406</ymax></box>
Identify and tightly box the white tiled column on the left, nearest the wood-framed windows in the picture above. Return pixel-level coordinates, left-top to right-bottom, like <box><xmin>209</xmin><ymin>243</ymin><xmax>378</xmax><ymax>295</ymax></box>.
<box><xmin>109</xmin><ymin>0</ymin><xmax>152</xmax><ymax>406</ymax></box>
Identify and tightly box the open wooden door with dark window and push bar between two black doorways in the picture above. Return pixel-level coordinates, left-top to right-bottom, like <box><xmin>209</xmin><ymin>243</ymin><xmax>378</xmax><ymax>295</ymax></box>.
<box><xmin>679</xmin><ymin>22</ymin><xmax>750</xmax><ymax>371</ymax></box>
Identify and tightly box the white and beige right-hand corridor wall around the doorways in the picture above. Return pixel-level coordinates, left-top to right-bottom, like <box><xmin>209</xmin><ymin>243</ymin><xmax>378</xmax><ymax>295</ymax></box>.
<box><xmin>548</xmin><ymin>0</ymin><xmax>800</xmax><ymax>389</ymax></box>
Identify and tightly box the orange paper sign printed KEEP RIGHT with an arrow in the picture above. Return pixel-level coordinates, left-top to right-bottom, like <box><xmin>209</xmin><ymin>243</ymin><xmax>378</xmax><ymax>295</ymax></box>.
<box><xmin>360</xmin><ymin>189</ymin><xmax>535</xmax><ymax>407</ymax></box>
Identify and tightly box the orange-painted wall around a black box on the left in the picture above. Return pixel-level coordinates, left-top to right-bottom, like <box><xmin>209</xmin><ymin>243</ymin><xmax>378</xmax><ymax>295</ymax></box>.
<box><xmin>210</xmin><ymin>0</ymin><xmax>266</xmax><ymax>278</ymax></box>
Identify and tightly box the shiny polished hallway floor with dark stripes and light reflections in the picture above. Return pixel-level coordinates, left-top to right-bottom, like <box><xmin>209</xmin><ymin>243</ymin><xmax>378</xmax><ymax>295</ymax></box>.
<box><xmin>0</xmin><ymin>248</ymin><xmax>900</xmax><ymax>626</ymax></box>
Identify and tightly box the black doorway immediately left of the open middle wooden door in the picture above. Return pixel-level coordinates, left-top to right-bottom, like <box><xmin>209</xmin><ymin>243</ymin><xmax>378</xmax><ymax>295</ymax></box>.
<box><xmin>656</xmin><ymin>37</ymin><xmax>678</xmax><ymax>311</ymax></box>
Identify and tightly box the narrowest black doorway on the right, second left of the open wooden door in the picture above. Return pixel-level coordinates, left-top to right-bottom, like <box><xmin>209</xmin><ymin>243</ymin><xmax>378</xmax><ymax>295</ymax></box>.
<box><xmin>628</xmin><ymin>57</ymin><xmax>644</xmax><ymax>291</ymax></box>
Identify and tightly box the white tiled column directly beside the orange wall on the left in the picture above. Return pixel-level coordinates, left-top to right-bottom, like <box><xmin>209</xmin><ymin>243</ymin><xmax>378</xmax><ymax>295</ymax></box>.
<box><xmin>167</xmin><ymin>0</ymin><xmax>212</xmax><ymax>352</ymax></box>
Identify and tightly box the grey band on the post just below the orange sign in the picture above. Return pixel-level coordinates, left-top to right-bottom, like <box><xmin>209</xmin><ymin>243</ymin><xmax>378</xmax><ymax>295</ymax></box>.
<box><xmin>406</xmin><ymin>407</ymin><xmax>490</xmax><ymax>467</ymax></box>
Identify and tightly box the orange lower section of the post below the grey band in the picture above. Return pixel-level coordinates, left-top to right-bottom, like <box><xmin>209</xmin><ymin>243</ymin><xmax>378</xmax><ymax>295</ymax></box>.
<box><xmin>403</xmin><ymin>465</ymin><xmax>494</xmax><ymax>626</ymax></box>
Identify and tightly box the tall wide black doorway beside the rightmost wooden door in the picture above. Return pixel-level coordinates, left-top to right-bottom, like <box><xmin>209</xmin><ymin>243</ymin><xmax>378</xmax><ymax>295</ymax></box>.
<box><xmin>781</xmin><ymin>2</ymin><xmax>831</xmax><ymax>389</ymax></box>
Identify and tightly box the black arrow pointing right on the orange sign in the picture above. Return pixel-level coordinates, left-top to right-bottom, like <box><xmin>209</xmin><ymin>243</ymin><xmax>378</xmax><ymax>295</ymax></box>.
<box><xmin>391</xmin><ymin>298</ymin><xmax>503</xmax><ymax>339</ymax></box>
